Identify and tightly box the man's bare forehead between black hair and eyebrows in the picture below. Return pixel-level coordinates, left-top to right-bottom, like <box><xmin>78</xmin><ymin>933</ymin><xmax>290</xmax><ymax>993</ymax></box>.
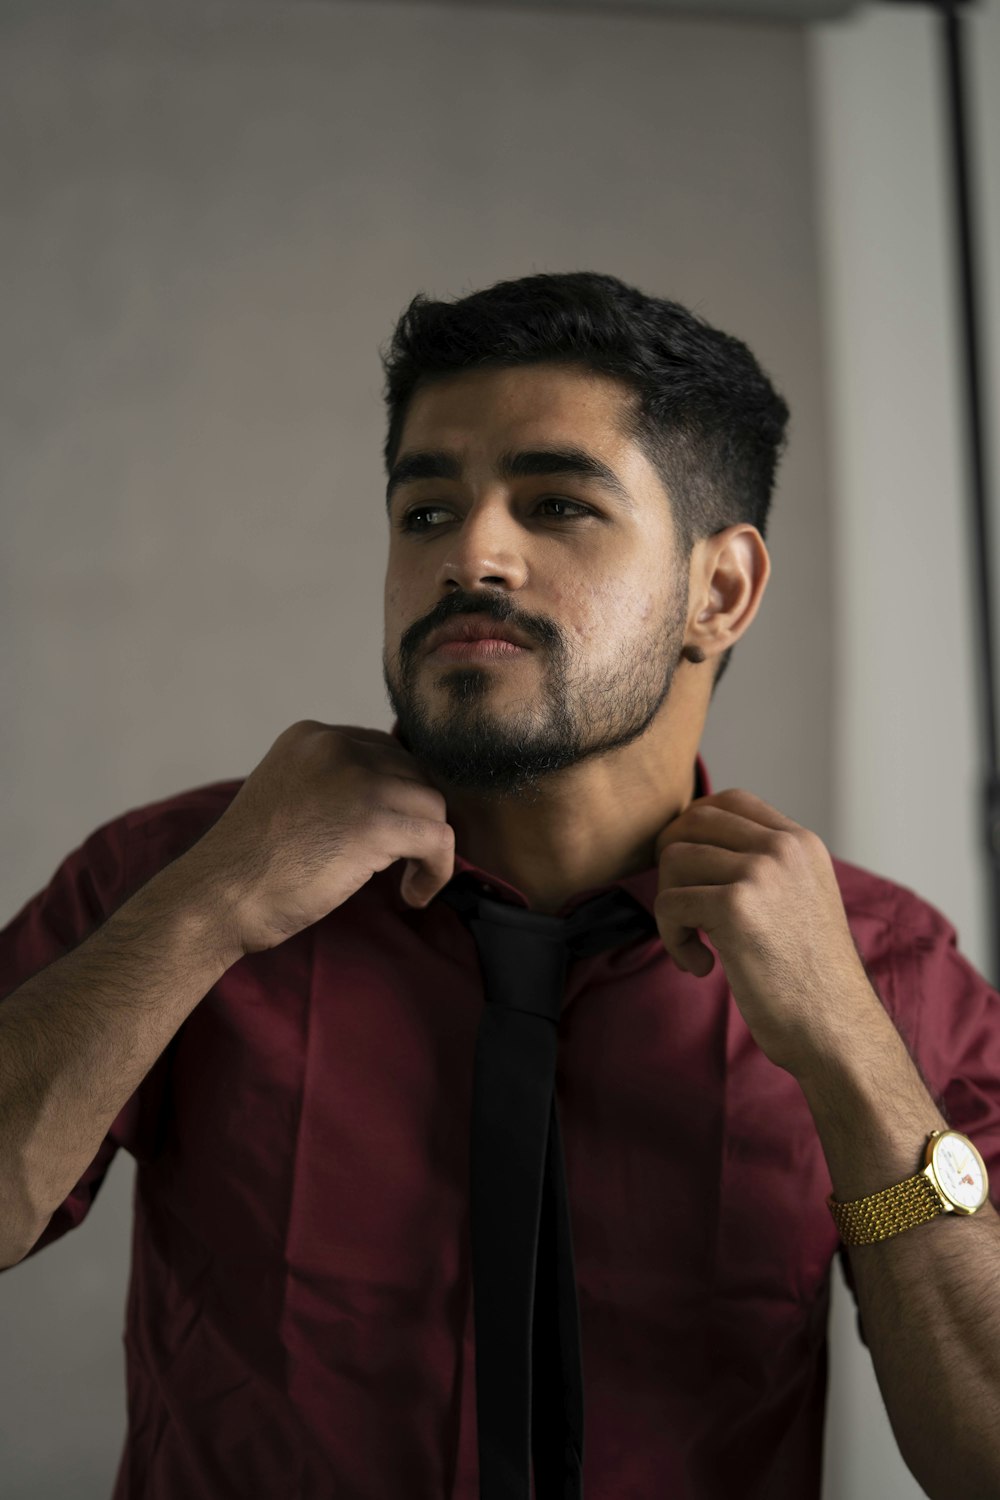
<box><xmin>399</xmin><ymin>365</ymin><xmax>633</xmax><ymax>459</ymax></box>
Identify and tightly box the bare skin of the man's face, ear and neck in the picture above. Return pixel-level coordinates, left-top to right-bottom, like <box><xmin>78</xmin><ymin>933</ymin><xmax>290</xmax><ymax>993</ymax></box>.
<box><xmin>384</xmin><ymin>366</ymin><xmax>771</xmax><ymax>912</ymax></box>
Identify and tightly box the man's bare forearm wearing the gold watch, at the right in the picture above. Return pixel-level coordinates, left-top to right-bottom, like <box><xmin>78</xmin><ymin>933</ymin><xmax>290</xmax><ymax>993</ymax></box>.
<box><xmin>799</xmin><ymin>992</ymin><xmax>1000</xmax><ymax>1500</ymax></box>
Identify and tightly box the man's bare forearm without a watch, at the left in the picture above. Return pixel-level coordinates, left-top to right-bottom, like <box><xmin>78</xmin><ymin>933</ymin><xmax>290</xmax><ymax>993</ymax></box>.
<box><xmin>0</xmin><ymin>854</ymin><xmax>240</xmax><ymax>1266</ymax></box>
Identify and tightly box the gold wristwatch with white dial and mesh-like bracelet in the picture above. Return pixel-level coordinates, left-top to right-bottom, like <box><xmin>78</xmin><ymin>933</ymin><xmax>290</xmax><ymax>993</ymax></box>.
<box><xmin>826</xmin><ymin>1130</ymin><xmax>990</xmax><ymax>1245</ymax></box>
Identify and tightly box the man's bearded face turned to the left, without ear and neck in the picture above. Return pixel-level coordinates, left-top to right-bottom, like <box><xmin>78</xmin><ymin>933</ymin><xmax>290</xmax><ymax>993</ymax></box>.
<box><xmin>382</xmin><ymin>365</ymin><xmax>688</xmax><ymax>795</ymax></box>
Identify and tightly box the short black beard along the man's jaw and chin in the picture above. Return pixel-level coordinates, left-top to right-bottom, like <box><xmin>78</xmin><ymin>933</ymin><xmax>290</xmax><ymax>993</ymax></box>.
<box><xmin>382</xmin><ymin>576</ymin><xmax>688</xmax><ymax>801</ymax></box>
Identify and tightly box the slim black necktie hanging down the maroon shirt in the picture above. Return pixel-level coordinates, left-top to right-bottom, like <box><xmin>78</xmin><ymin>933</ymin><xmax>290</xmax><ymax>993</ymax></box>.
<box><xmin>439</xmin><ymin>873</ymin><xmax>657</xmax><ymax>1500</ymax></box>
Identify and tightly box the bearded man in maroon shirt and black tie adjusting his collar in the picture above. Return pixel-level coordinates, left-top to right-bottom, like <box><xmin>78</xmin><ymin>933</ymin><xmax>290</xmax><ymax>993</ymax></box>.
<box><xmin>0</xmin><ymin>273</ymin><xmax>1000</xmax><ymax>1500</ymax></box>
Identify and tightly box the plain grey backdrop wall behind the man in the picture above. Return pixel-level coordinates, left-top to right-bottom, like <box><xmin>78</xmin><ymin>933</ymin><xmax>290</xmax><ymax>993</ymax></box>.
<box><xmin>0</xmin><ymin>0</ymin><xmax>985</xmax><ymax>1500</ymax></box>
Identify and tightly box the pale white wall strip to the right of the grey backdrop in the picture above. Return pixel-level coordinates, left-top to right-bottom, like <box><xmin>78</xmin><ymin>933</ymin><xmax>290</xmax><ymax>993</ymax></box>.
<box><xmin>810</xmin><ymin>0</ymin><xmax>1000</xmax><ymax>1500</ymax></box>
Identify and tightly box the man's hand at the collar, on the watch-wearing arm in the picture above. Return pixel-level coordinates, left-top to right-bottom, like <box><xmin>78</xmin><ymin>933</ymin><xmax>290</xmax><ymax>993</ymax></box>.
<box><xmin>654</xmin><ymin>788</ymin><xmax>885</xmax><ymax>1074</ymax></box>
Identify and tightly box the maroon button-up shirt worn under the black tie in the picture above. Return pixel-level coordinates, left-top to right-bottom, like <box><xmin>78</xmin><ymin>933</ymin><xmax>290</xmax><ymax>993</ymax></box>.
<box><xmin>0</xmin><ymin>741</ymin><xmax>1000</xmax><ymax>1500</ymax></box>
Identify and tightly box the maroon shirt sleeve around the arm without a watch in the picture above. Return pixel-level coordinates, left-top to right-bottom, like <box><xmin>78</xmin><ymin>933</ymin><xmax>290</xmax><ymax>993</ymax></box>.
<box><xmin>0</xmin><ymin>818</ymin><xmax>159</xmax><ymax>1254</ymax></box>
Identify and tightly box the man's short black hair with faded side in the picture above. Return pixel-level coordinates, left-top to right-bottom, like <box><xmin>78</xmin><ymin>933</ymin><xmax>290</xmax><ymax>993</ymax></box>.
<box><xmin>379</xmin><ymin>272</ymin><xmax>789</xmax><ymax>693</ymax></box>
